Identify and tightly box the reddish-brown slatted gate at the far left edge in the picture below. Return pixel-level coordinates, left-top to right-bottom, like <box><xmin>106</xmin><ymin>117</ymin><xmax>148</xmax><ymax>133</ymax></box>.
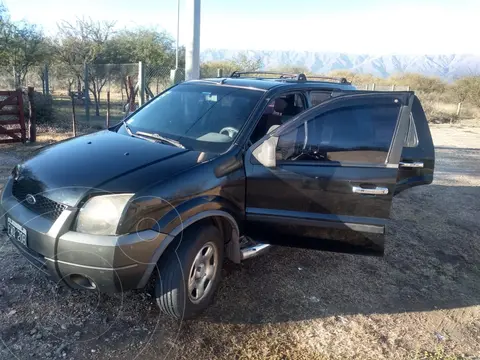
<box><xmin>0</xmin><ymin>90</ymin><xmax>26</xmax><ymax>144</ymax></box>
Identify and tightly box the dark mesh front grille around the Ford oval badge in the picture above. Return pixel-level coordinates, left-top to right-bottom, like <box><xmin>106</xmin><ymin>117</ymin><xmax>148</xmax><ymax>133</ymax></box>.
<box><xmin>12</xmin><ymin>182</ymin><xmax>67</xmax><ymax>221</ymax></box>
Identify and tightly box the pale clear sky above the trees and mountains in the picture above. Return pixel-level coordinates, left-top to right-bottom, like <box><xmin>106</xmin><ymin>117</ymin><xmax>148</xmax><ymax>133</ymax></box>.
<box><xmin>0</xmin><ymin>0</ymin><xmax>480</xmax><ymax>55</ymax></box>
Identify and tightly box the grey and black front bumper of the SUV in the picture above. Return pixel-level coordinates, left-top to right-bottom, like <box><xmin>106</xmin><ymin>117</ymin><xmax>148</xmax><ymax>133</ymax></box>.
<box><xmin>0</xmin><ymin>180</ymin><xmax>168</xmax><ymax>292</ymax></box>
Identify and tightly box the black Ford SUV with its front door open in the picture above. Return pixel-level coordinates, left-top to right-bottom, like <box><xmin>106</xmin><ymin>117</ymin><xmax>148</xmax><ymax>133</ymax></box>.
<box><xmin>0</xmin><ymin>72</ymin><xmax>434</xmax><ymax>318</ymax></box>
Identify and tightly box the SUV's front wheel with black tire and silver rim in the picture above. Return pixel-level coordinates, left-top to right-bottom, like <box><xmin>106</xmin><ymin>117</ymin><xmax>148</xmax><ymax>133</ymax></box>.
<box><xmin>154</xmin><ymin>225</ymin><xmax>224</xmax><ymax>319</ymax></box>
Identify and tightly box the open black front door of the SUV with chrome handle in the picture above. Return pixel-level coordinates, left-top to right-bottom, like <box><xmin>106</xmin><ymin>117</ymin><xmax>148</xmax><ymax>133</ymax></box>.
<box><xmin>245</xmin><ymin>92</ymin><xmax>414</xmax><ymax>255</ymax></box>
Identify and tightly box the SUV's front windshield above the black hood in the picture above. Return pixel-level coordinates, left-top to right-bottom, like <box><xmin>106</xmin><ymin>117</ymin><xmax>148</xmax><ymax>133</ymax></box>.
<box><xmin>118</xmin><ymin>84</ymin><xmax>263</xmax><ymax>152</ymax></box>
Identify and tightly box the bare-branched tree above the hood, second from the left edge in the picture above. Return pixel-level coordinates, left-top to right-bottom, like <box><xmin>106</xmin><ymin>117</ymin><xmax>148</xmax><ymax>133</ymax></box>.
<box><xmin>57</xmin><ymin>18</ymin><xmax>116</xmax><ymax>116</ymax></box>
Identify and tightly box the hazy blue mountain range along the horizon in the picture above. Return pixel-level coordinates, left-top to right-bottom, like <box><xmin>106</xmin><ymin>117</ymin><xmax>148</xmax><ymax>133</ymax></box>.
<box><xmin>201</xmin><ymin>49</ymin><xmax>480</xmax><ymax>80</ymax></box>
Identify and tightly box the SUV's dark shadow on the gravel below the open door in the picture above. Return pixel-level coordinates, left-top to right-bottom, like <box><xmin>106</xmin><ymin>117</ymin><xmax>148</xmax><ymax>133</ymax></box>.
<box><xmin>203</xmin><ymin>181</ymin><xmax>480</xmax><ymax>324</ymax></box>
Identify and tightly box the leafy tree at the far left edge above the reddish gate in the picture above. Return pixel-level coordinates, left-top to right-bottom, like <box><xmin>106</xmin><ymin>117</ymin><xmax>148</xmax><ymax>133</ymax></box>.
<box><xmin>0</xmin><ymin>4</ymin><xmax>51</xmax><ymax>87</ymax></box>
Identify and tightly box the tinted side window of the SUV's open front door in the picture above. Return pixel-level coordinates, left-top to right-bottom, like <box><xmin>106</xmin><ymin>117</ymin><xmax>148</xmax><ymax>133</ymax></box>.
<box><xmin>276</xmin><ymin>104</ymin><xmax>400</xmax><ymax>164</ymax></box>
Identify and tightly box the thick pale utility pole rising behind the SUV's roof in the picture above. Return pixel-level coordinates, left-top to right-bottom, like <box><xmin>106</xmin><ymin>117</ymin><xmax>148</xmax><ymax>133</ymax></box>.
<box><xmin>185</xmin><ymin>0</ymin><xmax>201</xmax><ymax>80</ymax></box>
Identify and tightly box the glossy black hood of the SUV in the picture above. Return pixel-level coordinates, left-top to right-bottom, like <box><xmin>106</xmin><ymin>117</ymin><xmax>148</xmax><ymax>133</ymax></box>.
<box><xmin>14</xmin><ymin>130</ymin><xmax>204</xmax><ymax>206</ymax></box>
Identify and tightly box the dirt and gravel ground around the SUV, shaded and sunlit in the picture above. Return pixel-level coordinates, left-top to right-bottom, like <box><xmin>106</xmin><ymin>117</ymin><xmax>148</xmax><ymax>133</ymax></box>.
<box><xmin>0</xmin><ymin>125</ymin><xmax>480</xmax><ymax>360</ymax></box>
